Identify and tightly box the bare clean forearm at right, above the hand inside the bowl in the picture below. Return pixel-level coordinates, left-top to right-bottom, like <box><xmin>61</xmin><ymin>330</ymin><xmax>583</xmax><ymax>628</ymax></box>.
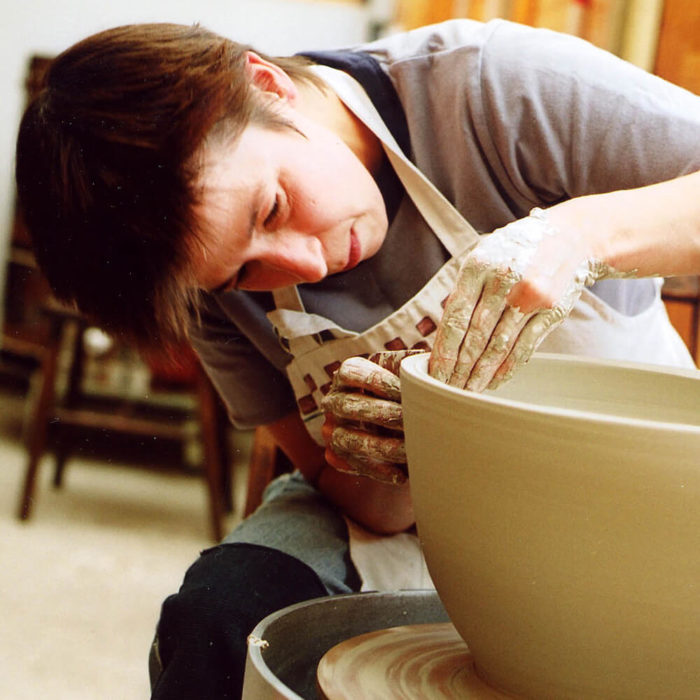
<box><xmin>547</xmin><ymin>171</ymin><xmax>700</xmax><ymax>277</ymax></box>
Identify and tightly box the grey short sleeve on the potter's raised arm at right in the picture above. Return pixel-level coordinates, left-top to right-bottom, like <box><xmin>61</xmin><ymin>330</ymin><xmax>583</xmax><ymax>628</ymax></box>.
<box><xmin>480</xmin><ymin>22</ymin><xmax>700</xmax><ymax>203</ymax></box>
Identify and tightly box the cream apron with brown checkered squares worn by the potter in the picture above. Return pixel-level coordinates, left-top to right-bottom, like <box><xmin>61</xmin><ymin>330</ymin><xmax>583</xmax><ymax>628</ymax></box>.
<box><xmin>267</xmin><ymin>66</ymin><xmax>693</xmax><ymax>590</ymax></box>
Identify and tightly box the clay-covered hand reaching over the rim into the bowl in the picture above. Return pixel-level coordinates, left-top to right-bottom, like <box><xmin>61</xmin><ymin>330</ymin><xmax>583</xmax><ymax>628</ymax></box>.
<box><xmin>429</xmin><ymin>209</ymin><xmax>621</xmax><ymax>391</ymax></box>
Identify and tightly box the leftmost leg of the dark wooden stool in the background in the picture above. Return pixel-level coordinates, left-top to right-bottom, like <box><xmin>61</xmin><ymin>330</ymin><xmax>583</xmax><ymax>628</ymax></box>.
<box><xmin>17</xmin><ymin>319</ymin><xmax>63</xmax><ymax>520</ymax></box>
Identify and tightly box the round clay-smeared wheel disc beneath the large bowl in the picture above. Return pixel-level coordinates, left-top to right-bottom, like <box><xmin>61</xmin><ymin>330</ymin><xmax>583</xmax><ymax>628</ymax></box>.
<box><xmin>316</xmin><ymin>623</ymin><xmax>507</xmax><ymax>700</ymax></box>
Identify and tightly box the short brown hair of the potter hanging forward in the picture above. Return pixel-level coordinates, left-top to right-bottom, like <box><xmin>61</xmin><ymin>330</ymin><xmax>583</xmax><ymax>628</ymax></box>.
<box><xmin>16</xmin><ymin>24</ymin><xmax>314</xmax><ymax>347</ymax></box>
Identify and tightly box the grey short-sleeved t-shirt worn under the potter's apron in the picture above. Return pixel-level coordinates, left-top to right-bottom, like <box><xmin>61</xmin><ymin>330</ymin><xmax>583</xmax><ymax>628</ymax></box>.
<box><xmin>192</xmin><ymin>20</ymin><xmax>700</xmax><ymax>427</ymax></box>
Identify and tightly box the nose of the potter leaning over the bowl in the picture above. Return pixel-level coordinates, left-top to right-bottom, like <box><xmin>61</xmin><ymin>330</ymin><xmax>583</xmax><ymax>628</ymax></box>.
<box><xmin>254</xmin><ymin>231</ymin><xmax>328</xmax><ymax>289</ymax></box>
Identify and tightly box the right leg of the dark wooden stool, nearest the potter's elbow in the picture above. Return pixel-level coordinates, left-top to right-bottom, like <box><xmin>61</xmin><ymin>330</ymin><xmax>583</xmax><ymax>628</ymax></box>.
<box><xmin>197</xmin><ymin>369</ymin><xmax>224</xmax><ymax>542</ymax></box>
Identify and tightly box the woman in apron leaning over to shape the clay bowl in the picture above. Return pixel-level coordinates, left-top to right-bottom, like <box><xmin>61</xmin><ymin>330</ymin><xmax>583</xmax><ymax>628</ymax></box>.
<box><xmin>17</xmin><ymin>21</ymin><xmax>700</xmax><ymax>698</ymax></box>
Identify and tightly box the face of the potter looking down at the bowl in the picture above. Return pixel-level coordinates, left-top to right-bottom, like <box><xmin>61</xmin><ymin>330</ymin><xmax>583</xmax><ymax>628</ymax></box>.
<box><xmin>194</xmin><ymin>105</ymin><xmax>387</xmax><ymax>291</ymax></box>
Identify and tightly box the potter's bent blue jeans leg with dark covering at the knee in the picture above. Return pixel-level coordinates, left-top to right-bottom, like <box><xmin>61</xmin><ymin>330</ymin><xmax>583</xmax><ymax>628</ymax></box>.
<box><xmin>150</xmin><ymin>473</ymin><xmax>361</xmax><ymax>700</ymax></box>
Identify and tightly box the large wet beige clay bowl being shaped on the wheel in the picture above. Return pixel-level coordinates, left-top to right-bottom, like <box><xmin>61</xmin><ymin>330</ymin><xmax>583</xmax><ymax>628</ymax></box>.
<box><xmin>401</xmin><ymin>355</ymin><xmax>700</xmax><ymax>700</ymax></box>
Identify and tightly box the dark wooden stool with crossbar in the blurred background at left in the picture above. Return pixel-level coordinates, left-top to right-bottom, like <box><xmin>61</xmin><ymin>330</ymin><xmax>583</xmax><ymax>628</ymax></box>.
<box><xmin>18</xmin><ymin>302</ymin><xmax>233</xmax><ymax>541</ymax></box>
